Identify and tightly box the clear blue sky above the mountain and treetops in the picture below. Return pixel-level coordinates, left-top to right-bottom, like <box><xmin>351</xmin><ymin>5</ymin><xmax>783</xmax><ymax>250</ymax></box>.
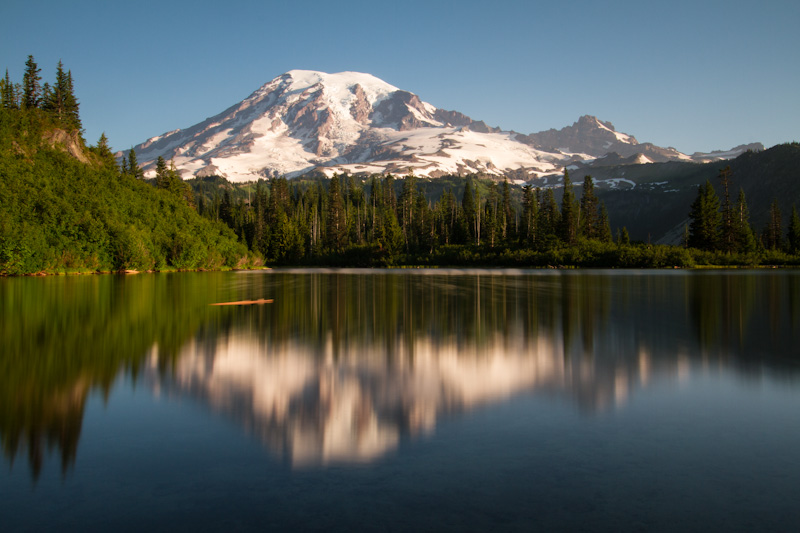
<box><xmin>0</xmin><ymin>0</ymin><xmax>800</xmax><ymax>153</ymax></box>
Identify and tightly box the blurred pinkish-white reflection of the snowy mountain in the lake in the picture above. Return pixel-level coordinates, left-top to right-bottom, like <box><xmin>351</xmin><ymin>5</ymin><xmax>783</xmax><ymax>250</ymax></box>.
<box><xmin>147</xmin><ymin>335</ymin><xmax>564</xmax><ymax>465</ymax></box>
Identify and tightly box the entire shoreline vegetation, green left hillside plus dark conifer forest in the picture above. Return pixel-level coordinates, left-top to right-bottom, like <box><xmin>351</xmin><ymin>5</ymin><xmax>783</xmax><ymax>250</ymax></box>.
<box><xmin>0</xmin><ymin>56</ymin><xmax>800</xmax><ymax>275</ymax></box>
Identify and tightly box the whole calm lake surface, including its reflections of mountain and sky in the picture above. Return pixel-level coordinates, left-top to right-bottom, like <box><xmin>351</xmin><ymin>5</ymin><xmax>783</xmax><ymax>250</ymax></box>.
<box><xmin>0</xmin><ymin>270</ymin><xmax>800</xmax><ymax>531</ymax></box>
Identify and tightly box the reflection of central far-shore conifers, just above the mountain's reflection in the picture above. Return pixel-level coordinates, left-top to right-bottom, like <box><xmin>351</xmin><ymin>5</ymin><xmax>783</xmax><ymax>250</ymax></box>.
<box><xmin>256</xmin><ymin>273</ymin><xmax>609</xmax><ymax>362</ymax></box>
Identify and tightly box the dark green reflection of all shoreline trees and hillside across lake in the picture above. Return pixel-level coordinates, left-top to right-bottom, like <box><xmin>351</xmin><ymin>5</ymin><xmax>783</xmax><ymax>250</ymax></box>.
<box><xmin>0</xmin><ymin>271</ymin><xmax>800</xmax><ymax>476</ymax></box>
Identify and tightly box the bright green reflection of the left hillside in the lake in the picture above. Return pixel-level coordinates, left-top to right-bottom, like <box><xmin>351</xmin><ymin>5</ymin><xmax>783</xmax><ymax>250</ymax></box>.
<box><xmin>0</xmin><ymin>274</ymin><xmax>236</xmax><ymax>478</ymax></box>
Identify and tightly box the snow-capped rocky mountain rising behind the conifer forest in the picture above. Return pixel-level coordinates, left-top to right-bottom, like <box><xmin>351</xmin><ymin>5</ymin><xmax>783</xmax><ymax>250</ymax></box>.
<box><xmin>125</xmin><ymin>70</ymin><xmax>760</xmax><ymax>181</ymax></box>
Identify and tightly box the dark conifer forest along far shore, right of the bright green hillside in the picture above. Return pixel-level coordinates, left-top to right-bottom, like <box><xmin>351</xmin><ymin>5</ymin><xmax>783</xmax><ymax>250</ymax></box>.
<box><xmin>184</xmin><ymin>161</ymin><xmax>800</xmax><ymax>267</ymax></box>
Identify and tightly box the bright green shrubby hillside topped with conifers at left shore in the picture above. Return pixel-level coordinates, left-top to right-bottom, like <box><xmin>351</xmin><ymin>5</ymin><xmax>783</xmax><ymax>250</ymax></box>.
<box><xmin>0</xmin><ymin>57</ymin><xmax>248</xmax><ymax>274</ymax></box>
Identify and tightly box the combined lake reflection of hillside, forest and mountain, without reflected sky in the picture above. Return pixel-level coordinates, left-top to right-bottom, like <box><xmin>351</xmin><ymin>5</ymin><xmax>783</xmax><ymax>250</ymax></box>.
<box><xmin>0</xmin><ymin>271</ymin><xmax>800</xmax><ymax>474</ymax></box>
